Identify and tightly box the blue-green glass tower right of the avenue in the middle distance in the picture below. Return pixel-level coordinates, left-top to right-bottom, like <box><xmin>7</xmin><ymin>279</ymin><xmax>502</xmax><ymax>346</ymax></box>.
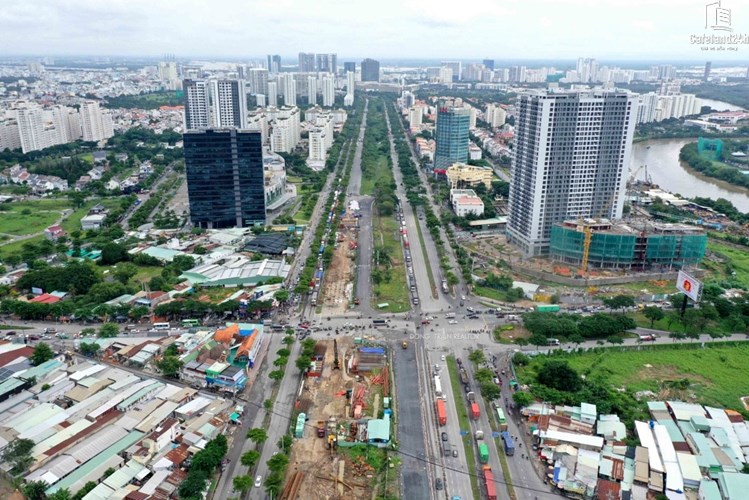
<box><xmin>434</xmin><ymin>107</ymin><xmax>471</xmax><ymax>168</ymax></box>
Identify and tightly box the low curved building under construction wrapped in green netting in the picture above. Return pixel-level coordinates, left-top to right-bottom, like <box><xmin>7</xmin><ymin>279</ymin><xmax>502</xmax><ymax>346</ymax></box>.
<box><xmin>550</xmin><ymin>219</ymin><xmax>707</xmax><ymax>269</ymax></box>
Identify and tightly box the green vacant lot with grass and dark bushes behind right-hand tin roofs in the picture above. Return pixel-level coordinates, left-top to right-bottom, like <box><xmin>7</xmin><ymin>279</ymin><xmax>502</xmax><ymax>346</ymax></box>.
<box><xmin>513</xmin><ymin>342</ymin><xmax>749</xmax><ymax>428</ymax></box>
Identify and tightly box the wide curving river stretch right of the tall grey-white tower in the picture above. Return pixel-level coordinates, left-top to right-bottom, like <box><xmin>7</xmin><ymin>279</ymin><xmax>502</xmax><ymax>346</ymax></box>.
<box><xmin>630</xmin><ymin>139</ymin><xmax>749</xmax><ymax>212</ymax></box>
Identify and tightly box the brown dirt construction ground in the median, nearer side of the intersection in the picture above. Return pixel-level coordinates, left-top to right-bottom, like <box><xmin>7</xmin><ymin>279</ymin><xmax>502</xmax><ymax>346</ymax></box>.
<box><xmin>287</xmin><ymin>337</ymin><xmax>382</xmax><ymax>500</ymax></box>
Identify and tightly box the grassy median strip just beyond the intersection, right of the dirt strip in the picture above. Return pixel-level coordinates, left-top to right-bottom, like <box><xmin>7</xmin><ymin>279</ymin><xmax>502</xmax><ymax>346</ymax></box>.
<box><xmin>372</xmin><ymin>216</ymin><xmax>410</xmax><ymax>312</ymax></box>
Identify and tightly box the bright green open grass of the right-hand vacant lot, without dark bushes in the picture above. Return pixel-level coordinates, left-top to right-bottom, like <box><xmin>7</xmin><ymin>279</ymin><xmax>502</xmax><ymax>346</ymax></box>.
<box><xmin>518</xmin><ymin>342</ymin><xmax>749</xmax><ymax>410</ymax></box>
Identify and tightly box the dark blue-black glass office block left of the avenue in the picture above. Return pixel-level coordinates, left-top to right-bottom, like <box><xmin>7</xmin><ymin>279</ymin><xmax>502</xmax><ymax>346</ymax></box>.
<box><xmin>183</xmin><ymin>129</ymin><xmax>265</xmax><ymax>229</ymax></box>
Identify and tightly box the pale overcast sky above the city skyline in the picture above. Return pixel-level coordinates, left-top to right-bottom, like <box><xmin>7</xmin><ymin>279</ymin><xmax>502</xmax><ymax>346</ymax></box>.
<box><xmin>0</xmin><ymin>0</ymin><xmax>749</xmax><ymax>63</ymax></box>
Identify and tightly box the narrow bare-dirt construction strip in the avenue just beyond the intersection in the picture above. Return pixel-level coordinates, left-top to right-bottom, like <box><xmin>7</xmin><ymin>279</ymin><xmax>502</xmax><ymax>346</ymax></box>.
<box><xmin>323</xmin><ymin>229</ymin><xmax>356</xmax><ymax>316</ymax></box>
